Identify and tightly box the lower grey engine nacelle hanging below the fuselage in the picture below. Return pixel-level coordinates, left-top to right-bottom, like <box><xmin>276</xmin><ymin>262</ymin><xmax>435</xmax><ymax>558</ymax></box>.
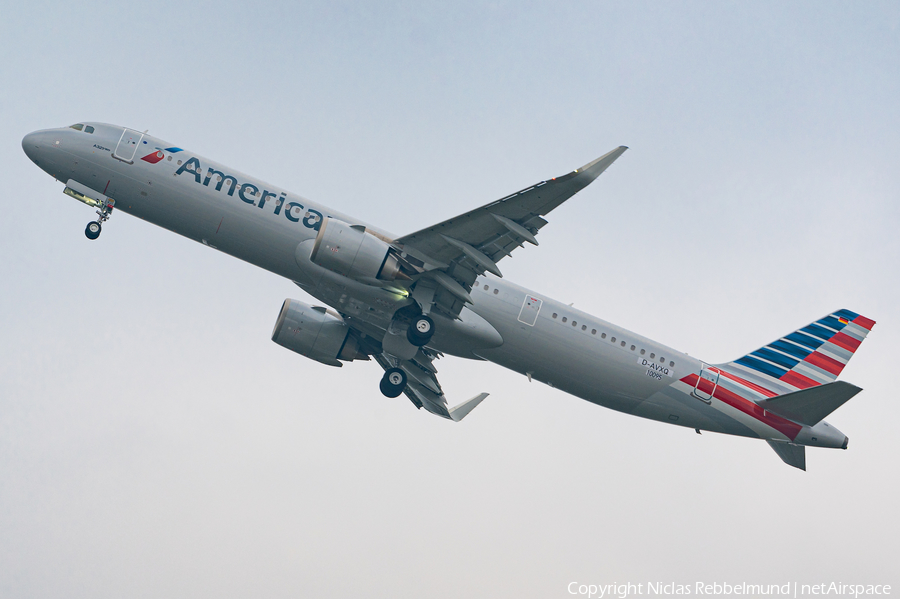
<box><xmin>272</xmin><ymin>299</ymin><xmax>368</xmax><ymax>366</ymax></box>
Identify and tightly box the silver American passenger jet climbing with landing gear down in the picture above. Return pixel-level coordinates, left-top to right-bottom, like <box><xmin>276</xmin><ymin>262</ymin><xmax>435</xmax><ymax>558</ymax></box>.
<box><xmin>22</xmin><ymin>122</ymin><xmax>875</xmax><ymax>470</ymax></box>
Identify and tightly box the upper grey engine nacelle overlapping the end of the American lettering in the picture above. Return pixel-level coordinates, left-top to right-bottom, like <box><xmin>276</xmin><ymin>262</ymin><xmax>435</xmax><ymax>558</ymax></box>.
<box><xmin>309</xmin><ymin>217</ymin><xmax>409</xmax><ymax>283</ymax></box>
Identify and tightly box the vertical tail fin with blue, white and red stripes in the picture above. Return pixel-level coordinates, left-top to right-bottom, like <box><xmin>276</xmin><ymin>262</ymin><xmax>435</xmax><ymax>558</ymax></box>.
<box><xmin>723</xmin><ymin>310</ymin><xmax>875</xmax><ymax>394</ymax></box>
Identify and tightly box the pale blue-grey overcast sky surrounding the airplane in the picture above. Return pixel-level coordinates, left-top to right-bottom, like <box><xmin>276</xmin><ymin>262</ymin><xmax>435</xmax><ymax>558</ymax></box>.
<box><xmin>0</xmin><ymin>1</ymin><xmax>900</xmax><ymax>598</ymax></box>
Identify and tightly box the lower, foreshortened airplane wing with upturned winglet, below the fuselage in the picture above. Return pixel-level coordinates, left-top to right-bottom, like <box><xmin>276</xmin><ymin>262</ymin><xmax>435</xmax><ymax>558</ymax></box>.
<box><xmin>374</xmin><ymin>348</ymin><xmax>488</xmax><ymax>422</ymax></box>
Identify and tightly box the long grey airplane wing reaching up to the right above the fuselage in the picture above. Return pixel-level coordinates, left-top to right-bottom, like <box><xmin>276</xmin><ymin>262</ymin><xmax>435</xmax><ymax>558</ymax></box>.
<box><xmin>393</xmin><ymin>146</ymin><xmax>628</xmax><ymax>317</ymax></box>
